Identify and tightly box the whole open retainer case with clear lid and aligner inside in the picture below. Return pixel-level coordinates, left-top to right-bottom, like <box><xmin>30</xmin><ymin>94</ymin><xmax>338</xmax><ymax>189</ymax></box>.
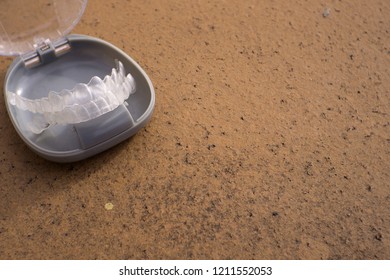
<box><xmin>0</xmin><ymin>0</ymin><xmax>155</xmax><ymax>162</ymax></box>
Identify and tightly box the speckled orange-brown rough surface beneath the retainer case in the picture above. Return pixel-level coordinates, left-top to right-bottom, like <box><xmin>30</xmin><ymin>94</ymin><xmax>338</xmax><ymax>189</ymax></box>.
<box><xmin>0</xmin><ymin>0</ymin><xmax>390</xmax><ymax>259</ymax></box>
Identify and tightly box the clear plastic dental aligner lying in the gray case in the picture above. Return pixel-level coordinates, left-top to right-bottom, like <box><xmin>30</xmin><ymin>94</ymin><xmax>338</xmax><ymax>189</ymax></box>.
<box><xmin>7</xmin><ymin>60</ymin><xmax>136</xmax><ymax>134</ymax></box>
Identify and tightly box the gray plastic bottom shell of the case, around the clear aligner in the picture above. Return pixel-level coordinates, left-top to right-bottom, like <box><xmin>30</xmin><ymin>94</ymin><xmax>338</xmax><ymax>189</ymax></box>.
<box><xmin>4</xmin><ymin>35</ymin><xmax>155</xmax><ymax>162</ymax></box>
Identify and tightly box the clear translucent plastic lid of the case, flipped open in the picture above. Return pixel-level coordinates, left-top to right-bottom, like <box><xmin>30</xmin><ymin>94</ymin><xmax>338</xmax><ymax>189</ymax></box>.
<box><xmin>0</xmin><ymin>0</ymin><xmax>87</xmax><ymax>55</ymax></box>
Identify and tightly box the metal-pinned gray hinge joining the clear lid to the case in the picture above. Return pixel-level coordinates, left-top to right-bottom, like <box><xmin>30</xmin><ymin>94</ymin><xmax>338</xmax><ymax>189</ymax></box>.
<box><xmin>21</xmin><ymin>38</ymin><xmax>71</xmax><ymax>68</ymax></box>
